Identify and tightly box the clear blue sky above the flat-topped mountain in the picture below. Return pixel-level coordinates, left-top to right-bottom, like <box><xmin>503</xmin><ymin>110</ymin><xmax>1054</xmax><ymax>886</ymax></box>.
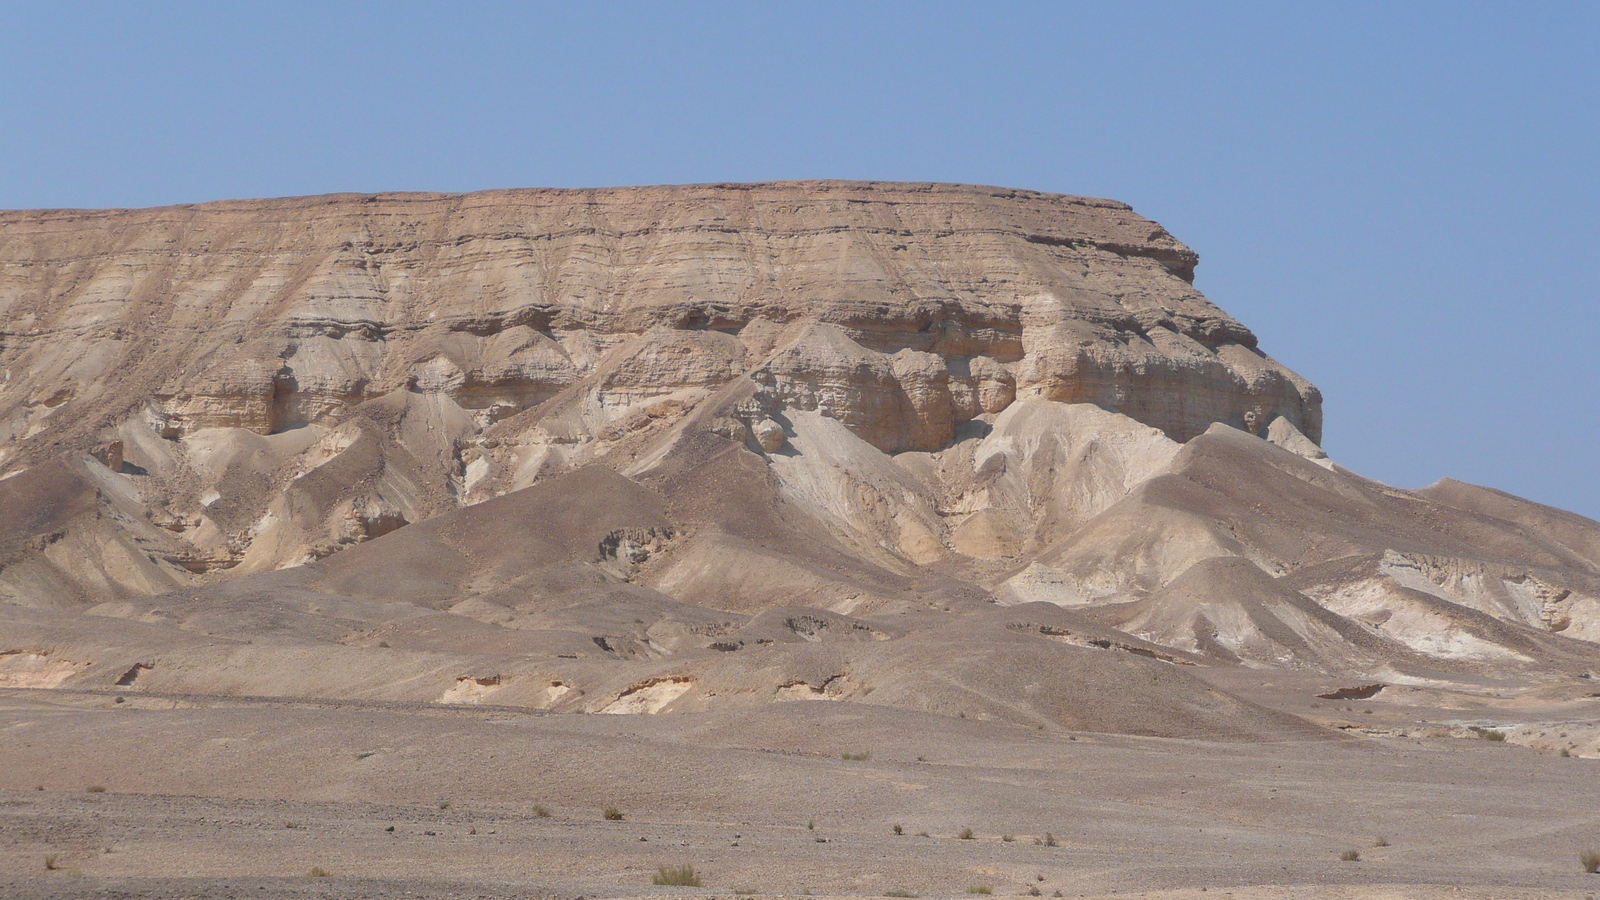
<box><xmin>0</xmin><ymin>0</ymin><xmax>1600</xmax><ymax>517</ymax></box>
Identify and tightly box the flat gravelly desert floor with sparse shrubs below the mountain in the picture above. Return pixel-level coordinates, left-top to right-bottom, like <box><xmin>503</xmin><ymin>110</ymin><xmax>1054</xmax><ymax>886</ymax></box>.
<box><xmin>0</xmin><ymin>690</ymin><xmax>1600</xmax><ymax>900</ymax></box>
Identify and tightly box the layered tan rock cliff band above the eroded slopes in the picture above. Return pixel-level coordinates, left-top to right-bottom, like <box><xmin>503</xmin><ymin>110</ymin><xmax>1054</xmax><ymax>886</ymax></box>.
<box><xmin>0</xmin><ymin>183</ymin><xmax>1322</xmax><ymax>452</ymax></box>
